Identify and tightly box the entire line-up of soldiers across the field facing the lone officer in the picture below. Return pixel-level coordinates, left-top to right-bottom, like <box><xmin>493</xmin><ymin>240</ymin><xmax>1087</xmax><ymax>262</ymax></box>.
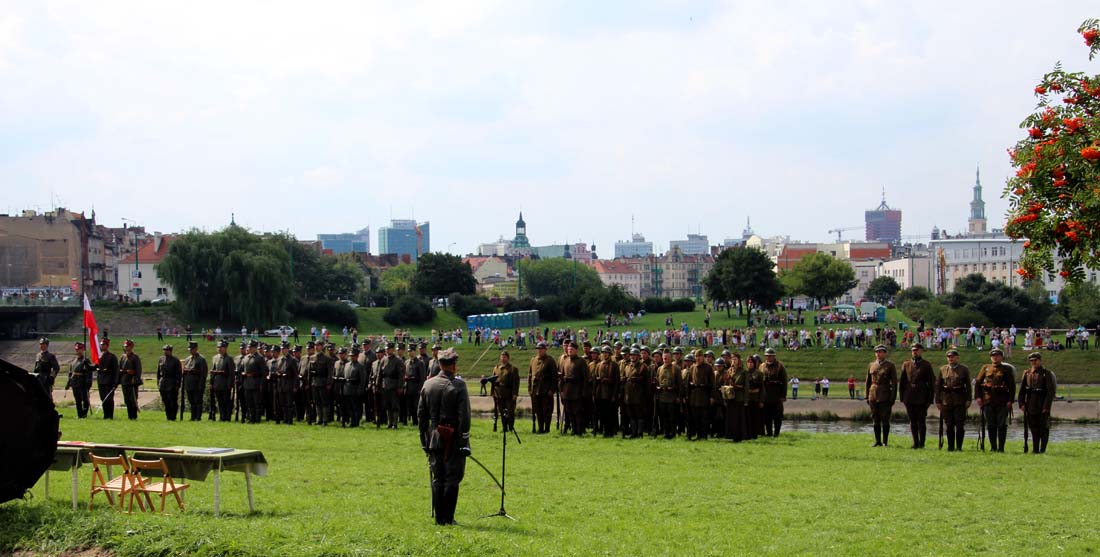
<box><xmin>49</xmin><ymin>330</ymin><xmax>1057</xmax><ymax>454</ymax></box>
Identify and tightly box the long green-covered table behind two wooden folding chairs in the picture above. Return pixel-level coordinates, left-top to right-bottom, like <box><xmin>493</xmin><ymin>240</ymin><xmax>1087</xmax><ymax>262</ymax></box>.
<box><xmin>45</xmin><ymin>441</ymin><xmax>267</xmax><ymax>516</ymax></box>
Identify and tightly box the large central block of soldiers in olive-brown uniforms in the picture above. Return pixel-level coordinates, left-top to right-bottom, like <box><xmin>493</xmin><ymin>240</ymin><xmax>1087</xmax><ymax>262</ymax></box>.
<box><xmin>493</xmin><ymin>341</ymin><xmax>787</xmax><ymax>441</ymax></box>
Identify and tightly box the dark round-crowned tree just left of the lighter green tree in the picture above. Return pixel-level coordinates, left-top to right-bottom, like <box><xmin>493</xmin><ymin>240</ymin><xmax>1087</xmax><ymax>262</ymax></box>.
<box><xmin>703</xmin><ymin>248</ymin><xmax>783</xmax><ymax>317</ymax></box>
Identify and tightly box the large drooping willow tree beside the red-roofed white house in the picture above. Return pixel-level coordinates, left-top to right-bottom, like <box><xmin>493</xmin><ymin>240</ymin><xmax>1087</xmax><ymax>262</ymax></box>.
<box><xmin>156</xmin><ymin>226</ymin><xmax>293</xmax><ymax>328</ymax></box>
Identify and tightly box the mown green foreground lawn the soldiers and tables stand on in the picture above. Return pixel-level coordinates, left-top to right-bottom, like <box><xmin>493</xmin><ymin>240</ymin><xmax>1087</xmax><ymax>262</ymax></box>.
<box><xmin>0</xmin><ymin>409</ymin><xmax>1100</xmax><ymax>556</ymax></box>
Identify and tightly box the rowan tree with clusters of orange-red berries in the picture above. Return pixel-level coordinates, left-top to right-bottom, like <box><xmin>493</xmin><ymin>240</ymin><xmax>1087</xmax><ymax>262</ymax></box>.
<box><xmin>1004</xmin><ymin>19</ymin><xmax>1100</xmax><ymax>283</ymax></box>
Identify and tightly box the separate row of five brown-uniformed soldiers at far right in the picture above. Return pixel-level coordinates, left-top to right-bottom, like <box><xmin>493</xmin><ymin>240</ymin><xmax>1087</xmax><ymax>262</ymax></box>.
<box><xmin>867</xmin><ymin>343</ymin><xmax>1057</xmax><ymax>454</ymax></box>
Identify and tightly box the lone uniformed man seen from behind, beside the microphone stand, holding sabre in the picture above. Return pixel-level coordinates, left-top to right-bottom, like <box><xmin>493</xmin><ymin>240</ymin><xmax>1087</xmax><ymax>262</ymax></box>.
<box><xmin>417</xmin><ymin>348</ymin><xmax>470</xmax><ymax>525</ymax></box>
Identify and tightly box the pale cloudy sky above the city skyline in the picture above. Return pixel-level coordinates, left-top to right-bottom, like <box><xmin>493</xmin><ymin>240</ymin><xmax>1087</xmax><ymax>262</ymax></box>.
<box><xmin>0</xmin><ymin>0</ymin><xmax>1100</xmax><ymax>256</ymax></box>
